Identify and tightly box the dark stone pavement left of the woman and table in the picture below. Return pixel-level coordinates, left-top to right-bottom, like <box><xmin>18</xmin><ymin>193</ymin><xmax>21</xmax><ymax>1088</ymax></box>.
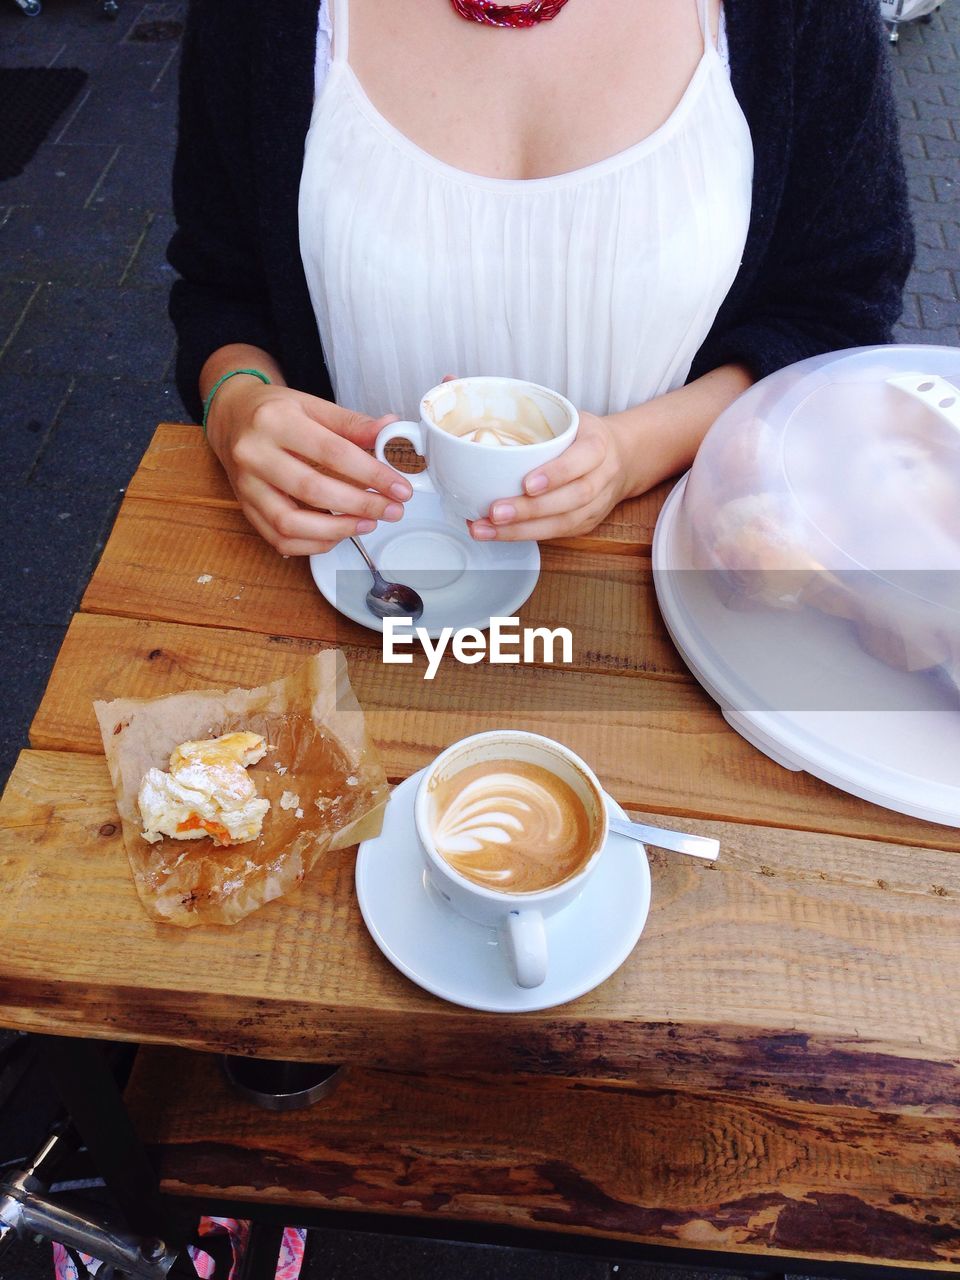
<box><xmin>0</xmin><ymin>0</ymin><xmax>186</xmax><ymax>781</ymax></box>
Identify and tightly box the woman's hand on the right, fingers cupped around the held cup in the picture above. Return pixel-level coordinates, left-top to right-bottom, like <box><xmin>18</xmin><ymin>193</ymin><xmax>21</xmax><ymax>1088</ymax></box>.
<box><xmin>470</xmin><ymin>413</ymin><xmax>631</xmax><ymax>541</ymax></box>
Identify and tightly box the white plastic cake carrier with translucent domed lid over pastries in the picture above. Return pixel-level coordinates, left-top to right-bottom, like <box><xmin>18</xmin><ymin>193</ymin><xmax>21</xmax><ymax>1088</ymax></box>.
<box><xmin>654</xmin><ymin>346</ymin><xmax>960</xmax><ymax>823</ymax></box>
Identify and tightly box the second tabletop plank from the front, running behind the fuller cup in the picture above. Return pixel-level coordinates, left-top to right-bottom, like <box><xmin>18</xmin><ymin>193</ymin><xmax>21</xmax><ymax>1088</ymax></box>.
<box><xmin>31</xmin><ymin>614</ymin><xmax>960</xmax><ymax>850</ymax></box>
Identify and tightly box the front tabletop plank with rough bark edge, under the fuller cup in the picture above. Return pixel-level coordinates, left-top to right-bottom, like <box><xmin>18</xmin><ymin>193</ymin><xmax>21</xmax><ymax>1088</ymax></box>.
<box><xmin>0</xmin><ymin>751</ymin><xmax>960</xmax><ymax>1116</ymax></box>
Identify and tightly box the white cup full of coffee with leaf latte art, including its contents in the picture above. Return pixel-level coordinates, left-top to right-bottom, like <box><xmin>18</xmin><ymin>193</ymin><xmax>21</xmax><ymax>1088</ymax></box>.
<box><xmin>413</xmin><ymin>730</ymin><xmax>607</xmax><ymax>987</ymax></box>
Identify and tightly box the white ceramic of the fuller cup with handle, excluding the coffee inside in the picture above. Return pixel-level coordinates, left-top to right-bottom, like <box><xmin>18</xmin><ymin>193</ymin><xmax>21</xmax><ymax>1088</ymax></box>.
<box><xmin>413</xmin><ymin>730</ymin><xmax>608</xmax><ymax>987</ymax></box>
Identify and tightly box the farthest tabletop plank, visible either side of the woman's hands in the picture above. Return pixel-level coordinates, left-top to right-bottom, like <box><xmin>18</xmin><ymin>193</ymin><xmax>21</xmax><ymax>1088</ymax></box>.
<box><xmin>127</xmin><ymin>422</ymin><xmax>673</xmax><ymax>556</ymax></box>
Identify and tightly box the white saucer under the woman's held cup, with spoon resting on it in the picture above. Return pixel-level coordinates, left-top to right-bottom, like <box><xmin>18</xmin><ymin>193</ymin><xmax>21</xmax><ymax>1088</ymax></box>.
<box><xmin>310</xmin><ymin>492</ymin><xmax>540</xmax><ymax>639</ymax></box>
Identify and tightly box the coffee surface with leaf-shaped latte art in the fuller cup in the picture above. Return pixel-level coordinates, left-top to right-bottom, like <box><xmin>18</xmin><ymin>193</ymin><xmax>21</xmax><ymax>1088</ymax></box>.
<box><xmin>433</xmin><ymin>760</ymin><xmax>593</xmax><ymax>893</ymax></box>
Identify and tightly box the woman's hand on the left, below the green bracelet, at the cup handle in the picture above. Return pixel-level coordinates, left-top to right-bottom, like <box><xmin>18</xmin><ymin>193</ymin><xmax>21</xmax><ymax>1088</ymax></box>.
<box><xmin>207</xmin><ymin>376</ymin><xmax>412</xmax><ymax>556</ymax></box>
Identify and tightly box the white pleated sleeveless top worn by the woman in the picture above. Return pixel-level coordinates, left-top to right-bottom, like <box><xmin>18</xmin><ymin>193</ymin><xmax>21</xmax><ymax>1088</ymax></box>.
<box><xmin>300</xmin><ymin>0</ymin><xmax>753</xmax><ymax>420</ymax></box>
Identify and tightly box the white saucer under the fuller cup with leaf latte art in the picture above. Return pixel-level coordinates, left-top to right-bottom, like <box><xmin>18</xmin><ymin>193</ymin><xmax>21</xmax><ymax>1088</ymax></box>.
<box><xmin>356</xmin><ymin>769</ymin><xmax>650</xmax><ymax>1014</ymax></box>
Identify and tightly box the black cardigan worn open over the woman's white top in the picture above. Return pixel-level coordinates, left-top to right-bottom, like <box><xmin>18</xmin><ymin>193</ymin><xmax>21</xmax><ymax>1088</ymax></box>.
<box><xmin>169</xmin><ymin>0</ymin><xmax>913</xmax><ymax>420</ymax></box>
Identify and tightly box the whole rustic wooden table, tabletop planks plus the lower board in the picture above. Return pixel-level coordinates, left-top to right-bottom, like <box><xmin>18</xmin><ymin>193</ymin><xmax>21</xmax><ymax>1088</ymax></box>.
<box><xmin>0</xmin><ymin>425</ymin><xmax>960</xmax><ymax>1270</ymax></box>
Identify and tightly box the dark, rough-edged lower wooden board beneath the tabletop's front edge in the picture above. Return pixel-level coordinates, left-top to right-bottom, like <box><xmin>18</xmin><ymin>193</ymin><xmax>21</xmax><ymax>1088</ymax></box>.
<box><xmin>127</xmin><ymin>1050</ymin><xmax>960</xmax><ymax>1270</ymax></box>
